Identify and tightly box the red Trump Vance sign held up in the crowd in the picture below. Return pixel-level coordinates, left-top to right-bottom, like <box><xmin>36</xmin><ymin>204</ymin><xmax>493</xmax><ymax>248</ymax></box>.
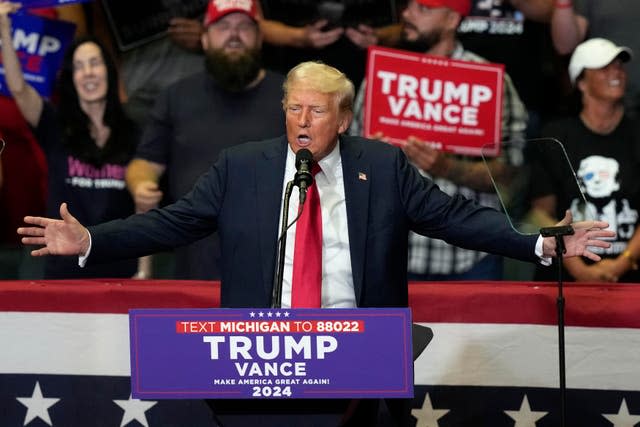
<box><xmin>364</xmin><ymin>46</ymin><xmax>504</xmax><ymax>156</ymax></box>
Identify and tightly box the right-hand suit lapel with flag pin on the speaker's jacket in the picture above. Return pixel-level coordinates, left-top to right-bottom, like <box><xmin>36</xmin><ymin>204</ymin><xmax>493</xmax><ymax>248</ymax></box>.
<box><xmin>340</xmin><ymin>136</ymin><xmax>371</xmax><ymax>305</ymax></box>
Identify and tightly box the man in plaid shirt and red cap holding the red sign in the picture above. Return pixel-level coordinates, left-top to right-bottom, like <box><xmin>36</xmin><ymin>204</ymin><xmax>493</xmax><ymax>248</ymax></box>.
<box><xmin>350</xmin><ymin>0</ymin><xmax>527</xmax><ymax>280</ymax></box>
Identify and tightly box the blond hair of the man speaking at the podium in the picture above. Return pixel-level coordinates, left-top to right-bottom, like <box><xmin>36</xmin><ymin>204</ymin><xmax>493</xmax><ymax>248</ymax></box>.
<box><xmin>282</xmin><ymin>61</ymin><xmax>355</xmax><ymax>112</ymax></box>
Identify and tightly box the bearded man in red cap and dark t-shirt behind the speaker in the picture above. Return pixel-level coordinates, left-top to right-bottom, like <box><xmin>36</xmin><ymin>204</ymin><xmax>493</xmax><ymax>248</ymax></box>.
<box><xmin>127</xmin><ymin>0</ymin><xmax>285</xmax><ymax>280</ymax></box>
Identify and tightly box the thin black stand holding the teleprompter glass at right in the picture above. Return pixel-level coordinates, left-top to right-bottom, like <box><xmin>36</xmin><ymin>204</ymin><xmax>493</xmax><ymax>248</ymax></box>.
<box><xmin>540</xmin><ymin>225</ymin><xmax>574</xmax><ymax>427</ymax></box>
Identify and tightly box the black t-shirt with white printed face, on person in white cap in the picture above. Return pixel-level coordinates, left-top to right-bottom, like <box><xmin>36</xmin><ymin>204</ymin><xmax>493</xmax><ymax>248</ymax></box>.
<box><xmin>531</xmin><ymin>118</ymin><xmax>640</xmax><ymax>282</ymax></box>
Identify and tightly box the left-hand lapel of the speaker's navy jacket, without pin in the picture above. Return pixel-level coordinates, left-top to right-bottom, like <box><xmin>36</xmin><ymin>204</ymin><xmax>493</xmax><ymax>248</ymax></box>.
<box><xmin>255</xmin><ymin>137</ymin><xmax>287</xmax><ymax>298</ymax></box>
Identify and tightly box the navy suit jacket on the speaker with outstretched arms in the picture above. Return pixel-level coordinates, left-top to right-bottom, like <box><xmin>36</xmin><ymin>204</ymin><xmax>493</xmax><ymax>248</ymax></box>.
<box><xmin>89</xmin><ymin>136</ymin><xmax>537</xmax><ymax>307</ymax></box>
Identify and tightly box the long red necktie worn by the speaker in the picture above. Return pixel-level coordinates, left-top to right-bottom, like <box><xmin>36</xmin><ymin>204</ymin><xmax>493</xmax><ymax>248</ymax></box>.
<box><xmin>291</xmin><ymin>164</ymin><xmax>322</xmax><ymax>308</ymax></box>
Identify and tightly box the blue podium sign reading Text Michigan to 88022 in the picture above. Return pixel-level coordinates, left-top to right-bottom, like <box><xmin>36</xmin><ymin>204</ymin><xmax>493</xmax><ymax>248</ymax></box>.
<box><xmin>129</xmin><ymin>308</ymin><xmax>413</xmax><ymax>399</ymax></box>
